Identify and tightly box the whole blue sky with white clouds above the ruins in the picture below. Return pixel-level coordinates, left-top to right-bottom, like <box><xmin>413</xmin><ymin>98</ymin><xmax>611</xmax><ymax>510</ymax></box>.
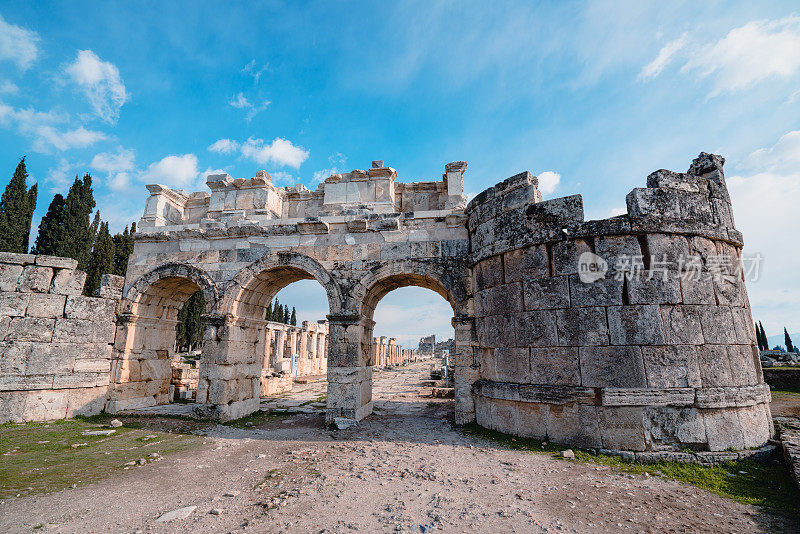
<box><xmin>0</xmin><ymin>1</ymin><xmax>800</xmax><ymax>344</ymax></box>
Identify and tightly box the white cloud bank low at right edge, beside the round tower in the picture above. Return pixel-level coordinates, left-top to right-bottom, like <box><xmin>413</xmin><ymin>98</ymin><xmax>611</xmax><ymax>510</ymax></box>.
<box><xmin>727</xmin><ymin>132</ymin><xmax>800</xmax><ymax>332</ymax></box>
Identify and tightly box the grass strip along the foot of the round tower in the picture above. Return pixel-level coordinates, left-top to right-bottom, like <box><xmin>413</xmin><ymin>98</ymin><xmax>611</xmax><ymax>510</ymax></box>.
<box><xmin>463</xmin><ymin>423</ymin><xmax>800</xmax><ymax>517</ymax></box>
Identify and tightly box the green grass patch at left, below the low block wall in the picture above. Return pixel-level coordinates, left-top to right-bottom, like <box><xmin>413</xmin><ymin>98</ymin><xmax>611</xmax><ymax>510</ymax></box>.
<box><xmin>0</xmin><ymin>416</ymin><xmax>203</xmax><ymax>499</ymax></box>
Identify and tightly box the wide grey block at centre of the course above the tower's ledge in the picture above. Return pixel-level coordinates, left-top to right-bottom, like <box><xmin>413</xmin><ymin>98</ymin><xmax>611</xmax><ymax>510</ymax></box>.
<box><xmin>580</xmin><ymin>346</ymin><xmax>647</xmax><ymax>388</ymax></box>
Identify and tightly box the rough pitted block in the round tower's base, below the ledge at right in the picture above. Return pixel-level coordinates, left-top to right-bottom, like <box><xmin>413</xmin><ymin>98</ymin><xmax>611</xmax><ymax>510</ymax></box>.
<box><xmin>642</xmin><ymin>407</ymin><xmax>708</xmax><ymax>451</ymax></box>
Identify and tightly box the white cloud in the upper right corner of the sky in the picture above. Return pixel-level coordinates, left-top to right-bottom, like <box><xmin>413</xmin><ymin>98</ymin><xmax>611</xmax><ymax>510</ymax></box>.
<box><xmin>682</xmin><ymin>16</ymin><xmax>800</xmax><ymax>96</ymax></box>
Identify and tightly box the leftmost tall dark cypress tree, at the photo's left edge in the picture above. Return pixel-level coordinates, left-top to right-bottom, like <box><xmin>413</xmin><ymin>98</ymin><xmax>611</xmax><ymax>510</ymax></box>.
<box><xmin>0</xmin><ymin>157</ymin><xmax>38</xmax><ymax>254</ymax></box>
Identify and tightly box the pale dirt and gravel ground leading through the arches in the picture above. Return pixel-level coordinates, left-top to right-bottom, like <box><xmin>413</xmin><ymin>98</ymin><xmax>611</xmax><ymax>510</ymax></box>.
<box><xmin>0</xmin><ymin>363</ymin><xmax>800</xmax><ymax>533</ymax></box>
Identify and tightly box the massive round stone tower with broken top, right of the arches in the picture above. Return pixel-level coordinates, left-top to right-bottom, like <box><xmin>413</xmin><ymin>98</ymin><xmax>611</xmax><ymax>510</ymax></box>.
<box><xmin>467</xmin><ymin>154</ymin><xmax>772</xmax><ymax>451</ymax></box>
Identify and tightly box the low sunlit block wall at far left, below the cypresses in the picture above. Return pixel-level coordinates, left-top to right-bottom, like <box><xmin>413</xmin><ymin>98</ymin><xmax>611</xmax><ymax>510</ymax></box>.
<box><xmin>0</xmin><ymin>253</ymin><xmax>123</xmax><ymax>423</ymax></box>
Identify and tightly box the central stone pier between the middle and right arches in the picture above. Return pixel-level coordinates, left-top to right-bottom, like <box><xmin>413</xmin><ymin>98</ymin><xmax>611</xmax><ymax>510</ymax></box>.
<box><xmin>325</xmin><ymin>315</ymin><xmax>374</xmax><ymax>423</ymax></box>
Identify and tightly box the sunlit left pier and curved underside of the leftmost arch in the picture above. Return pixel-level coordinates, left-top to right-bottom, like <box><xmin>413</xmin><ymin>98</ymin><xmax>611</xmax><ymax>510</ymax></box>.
<box><xmin>106</xmin><ymin>263</ymin><xmax>219</xmax><ymax>413</ymax></box>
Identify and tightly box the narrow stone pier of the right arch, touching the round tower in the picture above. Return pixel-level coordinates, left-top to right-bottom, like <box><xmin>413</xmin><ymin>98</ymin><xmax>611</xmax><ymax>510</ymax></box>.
<box><xmin>451</xmin><ymin>317</ymin><xmax>479</xmax><ymax>425</ymax></box>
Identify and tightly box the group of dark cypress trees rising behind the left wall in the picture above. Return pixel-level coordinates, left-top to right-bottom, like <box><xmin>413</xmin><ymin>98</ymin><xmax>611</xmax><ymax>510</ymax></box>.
<box><xmin>0</xmin><ymin>156</ymin><xmax>136</xmax><ymax>296</ymax></box>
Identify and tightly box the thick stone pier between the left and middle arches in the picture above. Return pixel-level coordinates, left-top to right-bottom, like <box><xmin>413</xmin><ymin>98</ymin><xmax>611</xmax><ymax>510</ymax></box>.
<box><xmin>196</xmin><ymin>314</ymin><xmax>267</xmax><ymax>421</ymax></box>
